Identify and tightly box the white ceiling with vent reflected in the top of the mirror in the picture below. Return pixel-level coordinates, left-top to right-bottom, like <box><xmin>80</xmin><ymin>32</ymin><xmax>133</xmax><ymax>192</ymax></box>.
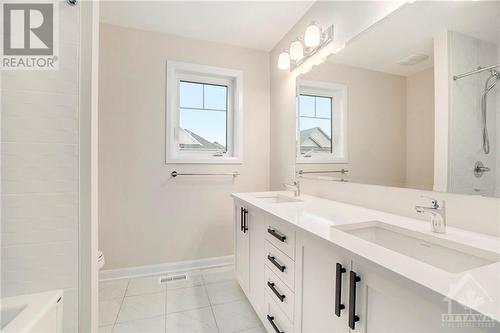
<box><xmin>329</xmin><ymin>1</ymin><xmax>500</xmax><ymax>76</ymax></box>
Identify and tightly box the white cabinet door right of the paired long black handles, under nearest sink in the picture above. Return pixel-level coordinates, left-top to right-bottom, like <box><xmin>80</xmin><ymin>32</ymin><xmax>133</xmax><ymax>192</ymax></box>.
<box><xmin>346</xmin><ymin>260</ymin><xmax>498</xmax><ymax>333</ymax></box>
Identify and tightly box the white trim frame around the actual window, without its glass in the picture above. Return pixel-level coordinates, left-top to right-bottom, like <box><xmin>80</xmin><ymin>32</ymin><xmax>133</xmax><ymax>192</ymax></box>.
<box><xmin>165</xmin><ymin>61</ymin><xmax>243</xmax><ymax>164</ymax></box>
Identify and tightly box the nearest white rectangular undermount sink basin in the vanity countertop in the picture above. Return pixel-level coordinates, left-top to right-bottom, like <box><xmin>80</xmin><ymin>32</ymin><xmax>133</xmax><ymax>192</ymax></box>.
<box><xmin>332</xmin><ymin>221</ymin><xmax>500</xmax><ymax>273</ymax></box>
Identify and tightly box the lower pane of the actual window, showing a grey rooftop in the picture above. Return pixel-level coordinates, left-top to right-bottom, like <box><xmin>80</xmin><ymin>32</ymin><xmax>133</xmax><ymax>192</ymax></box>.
<box><xmin>178</xmin><ymin>109</ymin><xmax>227</xmax><ymax>152</ymax></box>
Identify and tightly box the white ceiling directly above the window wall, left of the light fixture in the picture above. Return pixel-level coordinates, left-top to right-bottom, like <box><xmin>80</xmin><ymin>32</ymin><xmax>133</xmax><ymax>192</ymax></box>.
<box><xmin>101</xmin><ymin>0</ymin><xmax>314</xmax><ymax>51</ymax></box>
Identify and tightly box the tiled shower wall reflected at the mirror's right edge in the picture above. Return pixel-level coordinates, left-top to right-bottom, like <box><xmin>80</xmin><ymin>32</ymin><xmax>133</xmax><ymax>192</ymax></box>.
<box><xmin>448</xmin><ymin>32</ymin><xmax>498</xmax><ymax>196</ymax></box>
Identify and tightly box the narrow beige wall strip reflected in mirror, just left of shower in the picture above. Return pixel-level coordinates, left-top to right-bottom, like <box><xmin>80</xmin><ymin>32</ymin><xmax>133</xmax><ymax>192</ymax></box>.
<box><xmin>406</xmin><ymin>68</ymin><xmax>434</xmax><ymax>190</ymax></box>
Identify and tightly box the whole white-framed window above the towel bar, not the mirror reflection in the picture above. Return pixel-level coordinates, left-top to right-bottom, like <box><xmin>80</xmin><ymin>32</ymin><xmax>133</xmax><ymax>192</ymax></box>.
<box><xmin>166</xmin><ymin>62</ymin><xmax>241</xmax><ymax>164</ymax></box>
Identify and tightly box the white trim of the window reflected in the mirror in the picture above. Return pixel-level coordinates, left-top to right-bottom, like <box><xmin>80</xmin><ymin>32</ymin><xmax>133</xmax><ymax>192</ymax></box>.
<box><xmin>295</xmin><ymin>79</ymin><xmax>349</xmax><ymax>164</ymax></box>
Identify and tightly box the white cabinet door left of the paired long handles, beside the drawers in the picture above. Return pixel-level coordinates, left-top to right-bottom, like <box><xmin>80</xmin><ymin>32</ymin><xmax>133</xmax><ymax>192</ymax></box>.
<box><xmin>294</xmin><ymin>232</ymin><xmax>351</xmax><ymax>333</ymax></box>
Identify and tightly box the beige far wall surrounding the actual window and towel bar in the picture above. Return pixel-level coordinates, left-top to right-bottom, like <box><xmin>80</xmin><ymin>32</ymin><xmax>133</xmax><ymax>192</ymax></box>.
<box><xmin>99</xmin><ymin>24</ymin><xmax>270</xmax><ymax>269</ymax></box>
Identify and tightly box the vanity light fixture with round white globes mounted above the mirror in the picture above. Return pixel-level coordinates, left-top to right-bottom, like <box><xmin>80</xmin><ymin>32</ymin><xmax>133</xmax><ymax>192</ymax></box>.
<box><xmin>278</xmin><ymin>22</ymin><xmax>339</xmax><ymax>71</ymax></box>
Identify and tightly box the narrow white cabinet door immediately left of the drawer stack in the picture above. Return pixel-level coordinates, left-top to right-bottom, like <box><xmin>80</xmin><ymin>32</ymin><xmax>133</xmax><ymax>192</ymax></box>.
<box><xmin>247</xmin><ymin>210</ymin><xmax>266</xmax><ymax>316</ymax></box>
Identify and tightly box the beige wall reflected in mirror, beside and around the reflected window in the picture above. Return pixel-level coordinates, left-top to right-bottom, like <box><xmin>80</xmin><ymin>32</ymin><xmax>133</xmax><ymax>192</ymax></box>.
<box><xmin>297</xmin><ymin>63</ymin><xmax>406</xmax><ymax>186</ymax></box>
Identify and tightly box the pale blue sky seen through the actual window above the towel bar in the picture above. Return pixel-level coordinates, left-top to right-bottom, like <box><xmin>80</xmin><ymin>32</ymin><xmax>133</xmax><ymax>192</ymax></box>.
<box><xmin>179</xmin><ymin>81</ymin><xmax>227</xmax><ymax>147</ymax></box>
